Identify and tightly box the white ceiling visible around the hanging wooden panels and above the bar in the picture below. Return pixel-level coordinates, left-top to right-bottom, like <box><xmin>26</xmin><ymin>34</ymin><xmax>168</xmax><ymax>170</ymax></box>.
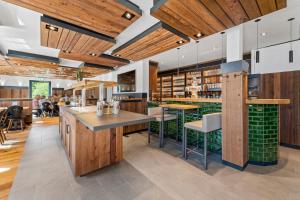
<box><xmin>0</xmin><ymin>0</ymin><xmax>300</xmax><ymax>70</ymax></box>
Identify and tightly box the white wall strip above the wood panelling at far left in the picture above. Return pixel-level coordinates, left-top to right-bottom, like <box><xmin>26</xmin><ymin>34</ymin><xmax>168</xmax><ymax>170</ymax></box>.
<box><xmin>0</xmin><ymin>75</ymin><xmax>76</xmax><ymax>88</ymax></box>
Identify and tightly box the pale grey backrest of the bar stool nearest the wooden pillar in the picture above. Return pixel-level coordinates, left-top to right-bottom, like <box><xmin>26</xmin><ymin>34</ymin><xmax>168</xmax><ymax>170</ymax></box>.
<box><xmin>202</xmin><ymin>113</ymin><xmax>222</xmax><ymax>133</ymax></box>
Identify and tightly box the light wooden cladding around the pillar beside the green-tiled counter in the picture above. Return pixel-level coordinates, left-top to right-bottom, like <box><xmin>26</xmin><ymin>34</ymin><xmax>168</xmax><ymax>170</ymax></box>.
<box><xmin>222</xmin><ymin>72</ymin><xmax>248</xmax><ymax>170</ymax></box>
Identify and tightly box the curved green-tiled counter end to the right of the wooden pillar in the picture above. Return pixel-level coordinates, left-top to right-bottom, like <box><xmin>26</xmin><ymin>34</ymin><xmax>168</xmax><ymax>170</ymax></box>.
<box><xmin>249</xmin><ymin>105</ymin><xmax>278</xmax><ymax>163</ymax></box>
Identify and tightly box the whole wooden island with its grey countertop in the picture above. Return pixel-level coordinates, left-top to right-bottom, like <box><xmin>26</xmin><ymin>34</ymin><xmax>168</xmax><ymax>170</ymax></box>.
<box><xmin>59</xmin><ymin>106</ymin><xmax>153</xmax><ymax>176</ymax></box>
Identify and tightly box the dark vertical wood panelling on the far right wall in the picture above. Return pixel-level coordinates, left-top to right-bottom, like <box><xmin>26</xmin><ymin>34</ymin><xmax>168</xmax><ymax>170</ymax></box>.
<box><xmin>259</xmin><ymin>71</ymin><xmax>300</xmax><ymax>146</ymax></box>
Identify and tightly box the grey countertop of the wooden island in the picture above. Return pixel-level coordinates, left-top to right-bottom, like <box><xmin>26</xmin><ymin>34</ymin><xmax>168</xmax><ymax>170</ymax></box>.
<box><xmin>64</xmin><ymin>107</ymin><xmax>155</xmax><ymax>131</ymax></box>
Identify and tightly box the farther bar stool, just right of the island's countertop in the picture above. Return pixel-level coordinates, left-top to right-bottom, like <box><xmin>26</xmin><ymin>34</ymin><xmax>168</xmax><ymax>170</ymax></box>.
<box><xmin>148</xmin><ymin>107</ymin><xmax>177</xmax><ymax>147</ymax></box>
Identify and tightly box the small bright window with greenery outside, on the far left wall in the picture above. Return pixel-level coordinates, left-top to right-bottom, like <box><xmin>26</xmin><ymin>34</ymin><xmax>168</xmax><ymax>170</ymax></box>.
<box><xmin>29</xmin><ymin>80</ymin><xmax>51</xmax><ymax>98</ymax></box>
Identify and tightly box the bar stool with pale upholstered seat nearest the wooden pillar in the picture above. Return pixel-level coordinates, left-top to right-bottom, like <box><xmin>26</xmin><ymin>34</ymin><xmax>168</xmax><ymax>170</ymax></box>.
<box><xmin>184</xmin><ymin>113</ymin><xmax>222</xmax><ymax>169</ymax></box>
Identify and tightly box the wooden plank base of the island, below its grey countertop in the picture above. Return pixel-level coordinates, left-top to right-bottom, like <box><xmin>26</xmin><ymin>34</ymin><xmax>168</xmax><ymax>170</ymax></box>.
<box><xmin>60</xmin><ymin>112</ymin><xmax>123</xmax><ymax>176</ymax></box>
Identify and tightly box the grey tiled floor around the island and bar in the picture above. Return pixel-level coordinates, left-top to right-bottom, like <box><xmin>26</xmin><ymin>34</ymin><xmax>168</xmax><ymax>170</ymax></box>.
<box><xmin>9</xmin><ymin>125</ymin><xmax>300</xmax><ymax>200</ymax></box>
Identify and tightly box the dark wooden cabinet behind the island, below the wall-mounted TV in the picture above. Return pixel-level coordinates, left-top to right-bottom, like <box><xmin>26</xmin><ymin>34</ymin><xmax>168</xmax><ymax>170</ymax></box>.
<box><xmin>120</xmin><ymin>99</ymin><xmax>148</xmax><ymax>134</ymax></box>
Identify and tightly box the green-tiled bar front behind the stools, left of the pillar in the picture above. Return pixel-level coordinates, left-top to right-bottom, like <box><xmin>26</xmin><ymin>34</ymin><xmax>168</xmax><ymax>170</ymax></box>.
<box><xmin>148</xmin><ymin>101</ymin><xmax>222</xmax><ymax>152</ymax></box>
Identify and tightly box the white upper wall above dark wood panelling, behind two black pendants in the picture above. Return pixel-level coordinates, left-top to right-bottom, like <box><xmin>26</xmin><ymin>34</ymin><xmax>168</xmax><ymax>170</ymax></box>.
<box><xmin>251</xmin><ymin>41</ymin><xmax>300</xmax><ymax>74</ymax></box>
